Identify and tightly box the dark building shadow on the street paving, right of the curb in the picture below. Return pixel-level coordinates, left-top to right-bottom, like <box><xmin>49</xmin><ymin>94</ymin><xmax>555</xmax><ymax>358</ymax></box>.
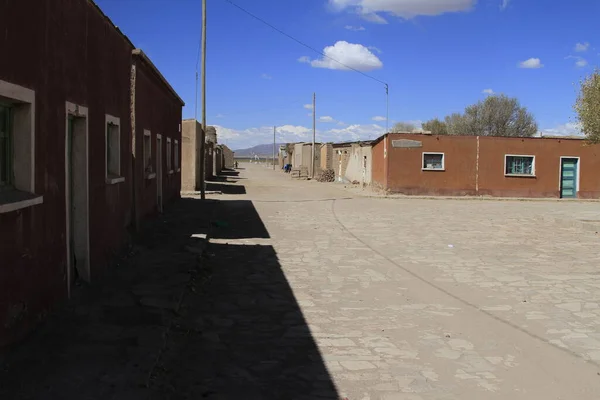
<box><xmin>156</xmin><ymin>201</ymin><xmax>339</xmax><ymax>400</ymax></box>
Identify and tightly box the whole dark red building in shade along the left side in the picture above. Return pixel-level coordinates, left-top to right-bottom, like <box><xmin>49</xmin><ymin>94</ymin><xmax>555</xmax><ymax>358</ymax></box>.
<box><xmin>0</xmin><ymin>0</ymin><xmax>183</xmax><ymax>347</ymax></box>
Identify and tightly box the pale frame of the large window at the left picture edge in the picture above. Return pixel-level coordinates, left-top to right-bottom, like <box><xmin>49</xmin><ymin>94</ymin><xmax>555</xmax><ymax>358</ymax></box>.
<box><xmin>0</xmin><ymin>80</ymin><xmax>44</xmax><ymax>214</ymax></box>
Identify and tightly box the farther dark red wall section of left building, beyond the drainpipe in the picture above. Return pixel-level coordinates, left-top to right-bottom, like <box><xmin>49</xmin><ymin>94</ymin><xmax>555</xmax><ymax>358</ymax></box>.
<box><xmin>134</xmin><ymin>61</ymin><xmax>182</xmax><ymax>222</ymax></box>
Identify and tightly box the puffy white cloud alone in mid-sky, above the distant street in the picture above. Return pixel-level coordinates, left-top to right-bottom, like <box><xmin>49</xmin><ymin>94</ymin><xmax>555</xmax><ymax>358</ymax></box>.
<box><xmin>302</xmin><ymin>41</ymin><xmax>383</xmax><ymax>71</ymax></box>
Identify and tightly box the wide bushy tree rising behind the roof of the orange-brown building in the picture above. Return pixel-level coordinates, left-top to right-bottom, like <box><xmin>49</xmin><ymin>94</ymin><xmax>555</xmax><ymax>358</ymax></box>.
<box><xmin>446</xmin><ymin>95</ymin><xmax>538</xmax><ymax>137</ymax></box>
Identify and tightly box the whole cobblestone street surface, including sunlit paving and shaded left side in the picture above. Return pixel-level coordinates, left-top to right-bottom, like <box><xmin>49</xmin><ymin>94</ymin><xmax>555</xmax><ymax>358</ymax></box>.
<box><xmin>0</xmin><ymin>164</ymin><xmax>600</xmax><ymax>400</ymax></box>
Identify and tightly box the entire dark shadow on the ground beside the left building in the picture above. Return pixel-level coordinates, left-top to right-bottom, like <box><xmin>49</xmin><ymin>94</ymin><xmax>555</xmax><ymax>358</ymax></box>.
<box><xmin>0</xmin><ymin>199</ymin><xmax>339</xmax><ymax>400</ymax></box>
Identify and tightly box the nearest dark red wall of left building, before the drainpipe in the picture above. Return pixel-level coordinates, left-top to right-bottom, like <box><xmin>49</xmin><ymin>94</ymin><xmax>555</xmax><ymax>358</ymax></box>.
<box><xmin>0</xmin><ymin>0</ymin><xmax>132</xmax><ymax>346</ymax></box>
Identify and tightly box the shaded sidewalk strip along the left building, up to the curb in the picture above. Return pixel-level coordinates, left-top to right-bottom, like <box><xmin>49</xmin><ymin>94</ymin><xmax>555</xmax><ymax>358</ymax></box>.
<box><xmin>0</xmin><ymin>199</ymin><xmax>217</xmax><ymax>400</ymax></box>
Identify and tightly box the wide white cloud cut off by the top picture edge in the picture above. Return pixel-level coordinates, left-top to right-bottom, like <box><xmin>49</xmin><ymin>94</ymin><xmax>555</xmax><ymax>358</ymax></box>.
<box><xmin>329</xmin><ymin>0</ymin><xmax>477</xmax><ymax>23</ymax></box>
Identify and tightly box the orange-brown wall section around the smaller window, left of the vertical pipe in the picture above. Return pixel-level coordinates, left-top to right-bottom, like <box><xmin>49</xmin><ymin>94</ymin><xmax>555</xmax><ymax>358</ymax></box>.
<box><xmin>384</xmin><ymin>134</ymin><xmax>477</xmax><ymax>196</ymax></box>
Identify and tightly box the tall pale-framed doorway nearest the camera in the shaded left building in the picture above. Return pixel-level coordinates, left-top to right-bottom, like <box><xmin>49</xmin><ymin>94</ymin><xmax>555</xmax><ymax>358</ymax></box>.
<box><xmin>65</xmin><ymin>103</ymin><xmax>90</xmax><ymax>296</ymax></box>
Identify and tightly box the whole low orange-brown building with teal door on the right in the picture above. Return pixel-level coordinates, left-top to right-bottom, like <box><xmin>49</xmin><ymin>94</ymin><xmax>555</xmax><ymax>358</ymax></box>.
<box><xmin>371</xmin><ymin>133</ymin><xmax>600</xmax><ymax>199</ymax></box>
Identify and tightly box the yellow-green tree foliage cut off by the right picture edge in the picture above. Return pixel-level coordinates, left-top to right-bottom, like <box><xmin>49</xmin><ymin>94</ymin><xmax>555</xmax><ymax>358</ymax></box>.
<box><xmin>575</xmin><ymin>70</ymin><xmax>600</xmax><ymax>143</ymax></box>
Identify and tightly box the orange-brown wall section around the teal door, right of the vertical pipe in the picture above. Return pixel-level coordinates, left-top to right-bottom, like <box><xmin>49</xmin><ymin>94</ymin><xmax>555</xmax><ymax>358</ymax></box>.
<box><xmin>479</xmin><ymin>137</ymin><xmax>600</xmax><ymax>198</ymax></box>
